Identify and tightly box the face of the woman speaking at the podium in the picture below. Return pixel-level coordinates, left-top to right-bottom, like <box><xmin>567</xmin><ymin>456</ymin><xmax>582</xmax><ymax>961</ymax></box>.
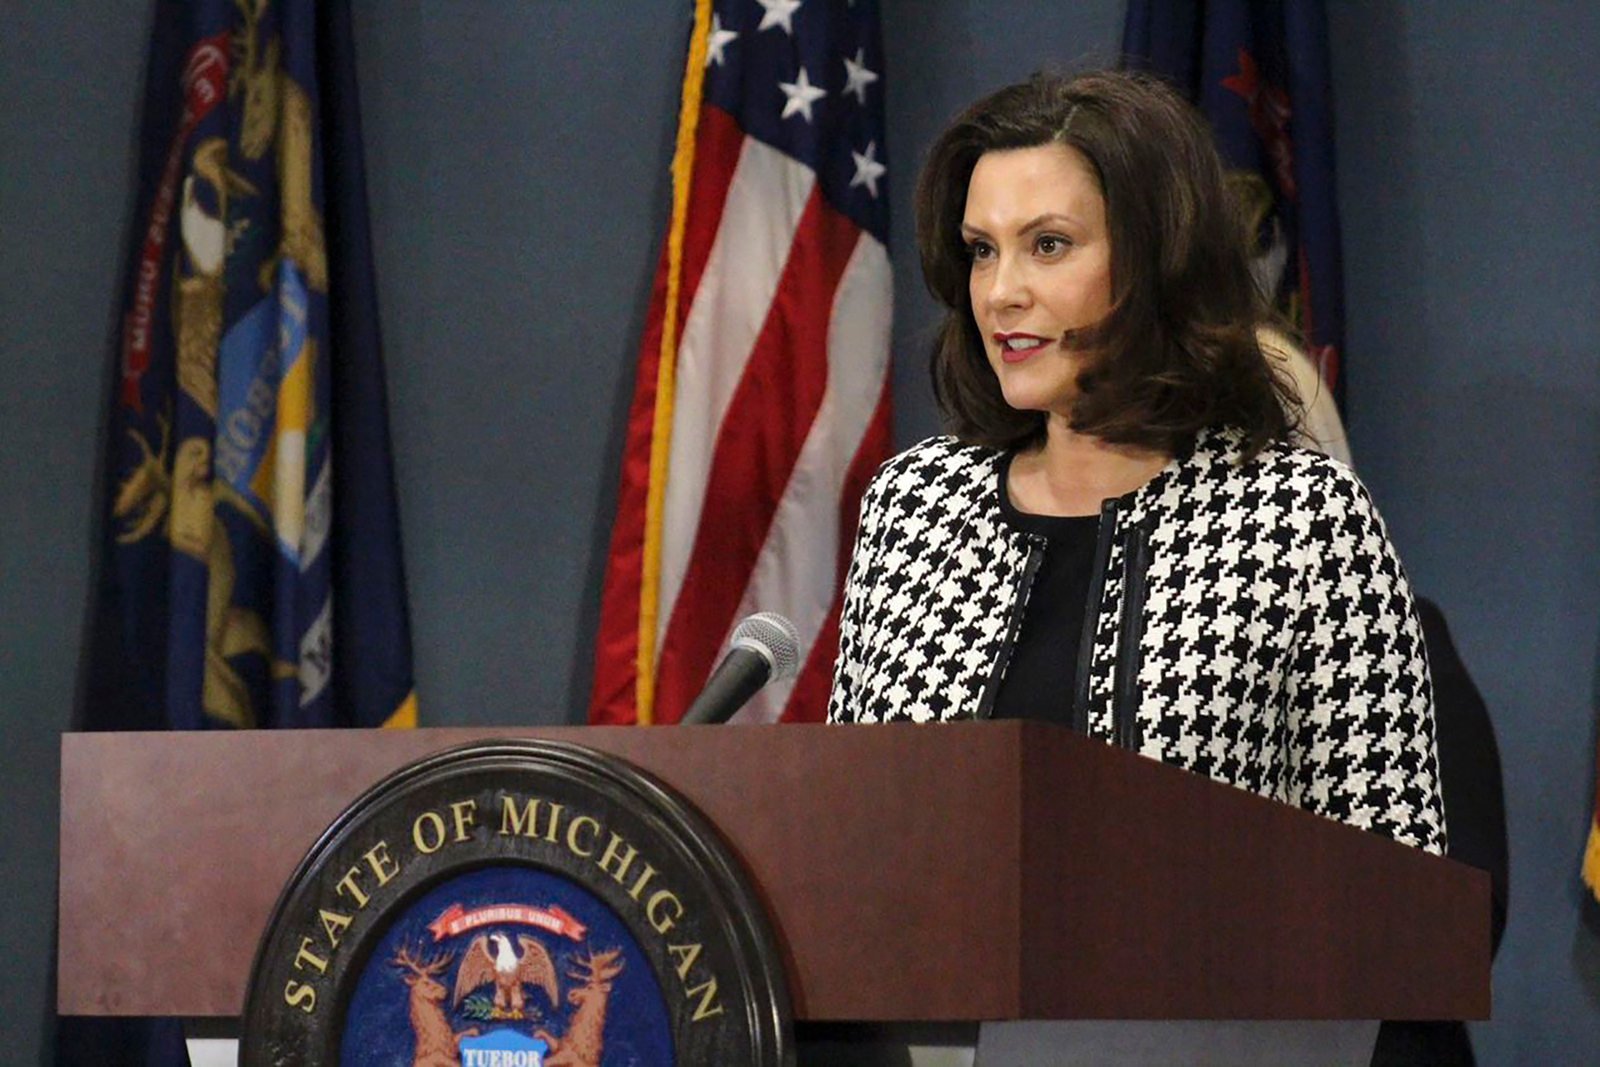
<box><xmin>962</xmin><ymin>144</ymin><xmax>1110</xmax><ymax>416</ymax></box>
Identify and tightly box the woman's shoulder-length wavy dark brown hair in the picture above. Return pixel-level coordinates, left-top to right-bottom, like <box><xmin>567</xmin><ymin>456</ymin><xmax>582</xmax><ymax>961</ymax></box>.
<box><xmin>915</xmin><ymin>72</ymin><xmax>1301</xmax><ymax>456</ymax></box>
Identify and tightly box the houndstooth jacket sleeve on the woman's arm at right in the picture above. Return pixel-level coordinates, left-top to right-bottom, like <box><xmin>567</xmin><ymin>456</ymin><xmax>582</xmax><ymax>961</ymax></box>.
<box><xmin>1283</xmin><ymin>462</ymin><xmax>1445</xmax><ymax>853</ymax></box>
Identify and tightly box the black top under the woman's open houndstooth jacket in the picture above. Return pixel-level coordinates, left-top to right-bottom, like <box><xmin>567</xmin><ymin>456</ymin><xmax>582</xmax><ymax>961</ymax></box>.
<box><xmin>994</xmin><ymin>458</ymin><xmax>1099</xmax><ymax>726</ymax></box>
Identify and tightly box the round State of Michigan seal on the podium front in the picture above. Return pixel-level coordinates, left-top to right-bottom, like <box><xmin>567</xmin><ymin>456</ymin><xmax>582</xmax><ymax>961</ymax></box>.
<box><xmin>240</xmin><ymin>741</ymin><xmax>794</xmax><ymax>1067</ymax></box>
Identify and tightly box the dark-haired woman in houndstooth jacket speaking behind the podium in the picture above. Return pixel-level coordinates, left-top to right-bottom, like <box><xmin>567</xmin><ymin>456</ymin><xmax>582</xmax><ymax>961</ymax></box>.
<box><xmin>829</xmin><ymin>74</ymin><xmax>1445</xmax><ymax>853</ymax></box>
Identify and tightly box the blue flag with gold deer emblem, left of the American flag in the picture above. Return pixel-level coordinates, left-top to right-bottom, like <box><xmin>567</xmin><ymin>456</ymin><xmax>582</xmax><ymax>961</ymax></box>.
<box><xmin>62</xmin><ymin>0</ymin><xmax>416</xmax><ymax>1064</ymax></box>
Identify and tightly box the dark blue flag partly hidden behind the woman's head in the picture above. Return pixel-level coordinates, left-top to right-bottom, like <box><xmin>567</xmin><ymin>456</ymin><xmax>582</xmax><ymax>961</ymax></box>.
<box><xmin>1122</xmin><ymin>0</ymin><xmax>1344</xmax><ymax>411</ymax></box>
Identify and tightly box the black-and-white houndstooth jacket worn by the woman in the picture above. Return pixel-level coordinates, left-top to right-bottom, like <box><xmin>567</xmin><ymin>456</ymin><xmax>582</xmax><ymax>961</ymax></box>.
<box><xmin>829</xmin><ymin>430</ymin><xmax>1445</xmax><ymax>853</ymax></box>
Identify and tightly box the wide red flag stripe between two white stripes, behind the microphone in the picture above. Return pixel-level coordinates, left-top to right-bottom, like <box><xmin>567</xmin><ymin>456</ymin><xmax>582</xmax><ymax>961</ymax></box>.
<box><xmin>656</xmin><ymin>187</ymin><xmax>861</xmax><ymax>721</ymax></box>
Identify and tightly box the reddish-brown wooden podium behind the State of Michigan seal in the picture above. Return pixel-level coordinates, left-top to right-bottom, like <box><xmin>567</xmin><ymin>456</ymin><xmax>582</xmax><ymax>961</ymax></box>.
<box><xmin>58</xmin><ymin>723</ymin><xmax>1490</xmax><ymax>1024</ymax></box>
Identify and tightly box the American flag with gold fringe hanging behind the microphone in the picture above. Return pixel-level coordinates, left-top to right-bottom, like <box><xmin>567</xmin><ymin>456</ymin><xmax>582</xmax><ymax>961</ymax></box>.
<box><xmin>589</xmin><ymin>0</ymin><xmax>891</xmax><ymax>723</ymax></box>
